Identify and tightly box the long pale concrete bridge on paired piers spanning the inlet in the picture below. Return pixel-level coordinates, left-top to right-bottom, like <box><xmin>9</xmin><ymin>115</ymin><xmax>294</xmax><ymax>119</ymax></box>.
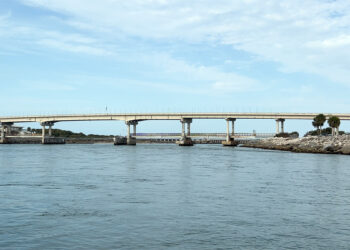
<box><xmin>0</xmin><ymin>113</ymin><xmax>350</xmax><ymax>146</ymax></box>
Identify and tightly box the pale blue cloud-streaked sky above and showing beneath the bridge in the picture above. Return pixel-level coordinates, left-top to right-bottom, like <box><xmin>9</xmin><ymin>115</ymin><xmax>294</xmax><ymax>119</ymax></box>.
<box><xmin>0</xmin><ymin>0</ymin><xmax>350</xmax><ymax>134</ymax></box>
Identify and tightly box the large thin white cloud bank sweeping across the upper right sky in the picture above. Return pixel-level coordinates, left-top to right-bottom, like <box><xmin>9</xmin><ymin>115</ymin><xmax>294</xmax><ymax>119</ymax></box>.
<box><xmin>21</xmin><ymin>0</ymin><xmax>350</xmax><ymax>83</ymax></box>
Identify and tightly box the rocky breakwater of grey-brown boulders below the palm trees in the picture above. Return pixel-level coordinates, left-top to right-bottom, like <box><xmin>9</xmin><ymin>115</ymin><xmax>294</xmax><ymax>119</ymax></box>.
<box><xmin>241</xmin><ymin>135</ymin><xmax>350</xmax><ymax>155</ymax></box>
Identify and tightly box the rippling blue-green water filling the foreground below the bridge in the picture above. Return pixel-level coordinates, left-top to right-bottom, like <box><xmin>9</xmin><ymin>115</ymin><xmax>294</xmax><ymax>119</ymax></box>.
<box><xmin>0</xmin><ymin>144</ymin><xmax>350</xmax><ymax>249</ymax></box>
